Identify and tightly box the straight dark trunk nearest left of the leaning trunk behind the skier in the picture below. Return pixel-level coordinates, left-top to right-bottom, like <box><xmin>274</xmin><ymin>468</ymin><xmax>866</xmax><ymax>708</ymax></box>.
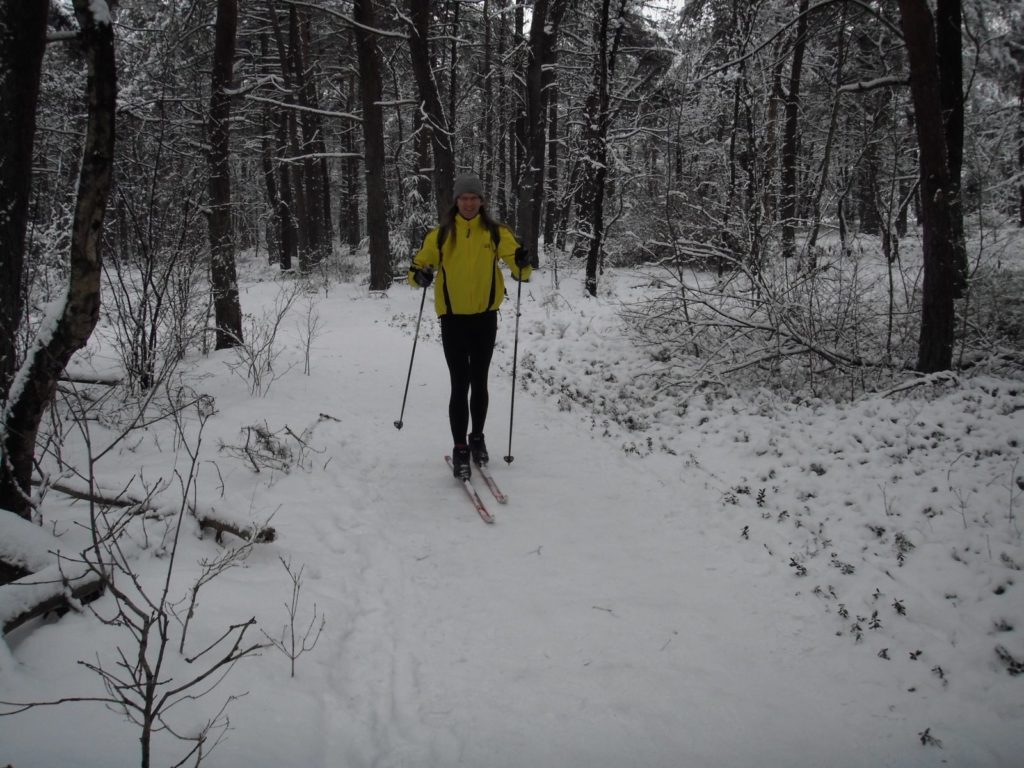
<box><xmin>352</xmin><ymin>0</ymin><xmax>391</xmax><ymax>291</ymax></box>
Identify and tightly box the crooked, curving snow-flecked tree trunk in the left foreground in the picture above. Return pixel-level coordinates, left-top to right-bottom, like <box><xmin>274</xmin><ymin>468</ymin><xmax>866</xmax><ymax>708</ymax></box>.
<box><xmin>0</xmin><ymin>0</ymin><xmax>117</xmax><ymax>518</ymax></box>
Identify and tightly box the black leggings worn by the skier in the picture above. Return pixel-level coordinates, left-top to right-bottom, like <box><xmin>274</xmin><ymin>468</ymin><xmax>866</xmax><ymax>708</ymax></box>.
<box><xmin>440</xmin><ymin>311</ymin><xmax>498</xmax><ymax>445</ymax></box>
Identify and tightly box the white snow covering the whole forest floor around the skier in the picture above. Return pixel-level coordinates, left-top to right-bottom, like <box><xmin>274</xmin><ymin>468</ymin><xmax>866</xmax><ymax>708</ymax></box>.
<box><xmin>0</xmin><ymin>253</ymin><xmax>1024</xmax><ymax>768</ymax></box>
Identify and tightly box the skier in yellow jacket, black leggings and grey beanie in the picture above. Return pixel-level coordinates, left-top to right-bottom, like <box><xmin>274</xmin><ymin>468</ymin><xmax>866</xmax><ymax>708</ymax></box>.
<box><xmin>409</xmin><ymin>174</ymin><xmax>531</xmax><ymax>480</ymax></box>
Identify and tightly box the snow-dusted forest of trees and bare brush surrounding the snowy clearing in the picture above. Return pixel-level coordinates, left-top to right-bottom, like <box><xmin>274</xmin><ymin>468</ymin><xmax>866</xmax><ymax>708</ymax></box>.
<box><xmin>0</xmin><ymin>0</ymin><xmax>1024</xmax><ymax>765</ymax></box>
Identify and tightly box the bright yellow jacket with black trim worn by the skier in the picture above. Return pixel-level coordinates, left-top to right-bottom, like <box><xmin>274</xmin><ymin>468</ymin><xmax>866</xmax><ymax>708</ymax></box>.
<box><xmin>409</xmin><ymin>214</ymin><xmax>532</xmax><ymax>316</ymax></box>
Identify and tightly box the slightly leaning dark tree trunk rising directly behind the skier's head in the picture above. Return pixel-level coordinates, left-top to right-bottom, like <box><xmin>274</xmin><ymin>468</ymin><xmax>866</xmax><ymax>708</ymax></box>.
<box><xmin>407</xmin><ymin>0</ymin><xmax>455</xmax><ymax>217</ymax></box>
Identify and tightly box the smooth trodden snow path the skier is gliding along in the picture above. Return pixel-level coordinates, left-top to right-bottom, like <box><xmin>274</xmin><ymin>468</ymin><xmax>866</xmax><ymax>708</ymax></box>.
<box><xmin>207</xmin><ymin>289</ymin><xmax>974</xmax><ymax>768</ymax></box>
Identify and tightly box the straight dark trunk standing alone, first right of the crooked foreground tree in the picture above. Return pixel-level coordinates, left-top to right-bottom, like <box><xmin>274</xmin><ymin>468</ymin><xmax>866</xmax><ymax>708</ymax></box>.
<box><xmin>208</xmin><ymin>0</ymin><xmax>242</xmax><ymax>349</ymax></box>
